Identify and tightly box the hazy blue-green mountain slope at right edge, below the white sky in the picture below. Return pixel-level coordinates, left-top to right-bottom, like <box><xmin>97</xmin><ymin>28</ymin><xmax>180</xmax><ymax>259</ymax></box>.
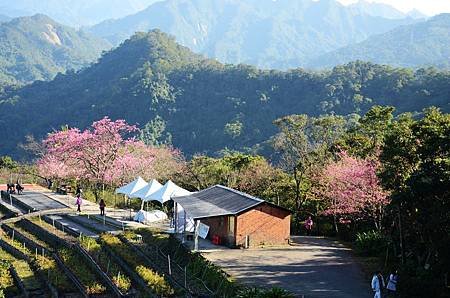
<box><xmin>309</xmin><ymin>14</ymin><xmax>450</xmax><ymax>67</ymax></box>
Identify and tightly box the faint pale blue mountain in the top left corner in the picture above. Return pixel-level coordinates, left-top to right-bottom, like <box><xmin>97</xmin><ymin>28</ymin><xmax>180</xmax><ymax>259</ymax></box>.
<box><xmin>0</xmin><ymin>0</ymin><xmax>157</xmax><ymax>27</ymax></box>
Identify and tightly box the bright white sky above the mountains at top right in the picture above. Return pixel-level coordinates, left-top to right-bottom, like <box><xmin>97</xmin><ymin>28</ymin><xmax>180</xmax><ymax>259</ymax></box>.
<box><xmin>338</xmin><ymin>0</ymin><xmax>450</xmax><ymax>15</ymax></box>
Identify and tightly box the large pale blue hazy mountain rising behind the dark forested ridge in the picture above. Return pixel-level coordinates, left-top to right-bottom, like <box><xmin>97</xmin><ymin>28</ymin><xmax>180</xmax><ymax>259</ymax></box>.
<box><xmin>90</xmin><ymin>0</ymin><xmax>416</xmax><ymax>69</ymax></box>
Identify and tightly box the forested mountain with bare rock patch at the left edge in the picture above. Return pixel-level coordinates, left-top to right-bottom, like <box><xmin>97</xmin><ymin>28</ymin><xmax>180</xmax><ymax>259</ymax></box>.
<box><xmin>0</xmin><ymin>15</ymin><xmax>111</xmax><ymax>85</ymax></box>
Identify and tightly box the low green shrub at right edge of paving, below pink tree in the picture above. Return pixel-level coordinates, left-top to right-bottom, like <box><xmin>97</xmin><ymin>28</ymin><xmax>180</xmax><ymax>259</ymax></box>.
<box><xmin>355</xmin><ymin>231</ymin><xmax>388</xmax><ymax>256</ymax></box>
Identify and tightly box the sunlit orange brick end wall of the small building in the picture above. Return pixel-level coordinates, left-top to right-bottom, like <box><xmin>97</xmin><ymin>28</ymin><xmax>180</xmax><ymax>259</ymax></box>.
<box><xmin>236</xmin><ymin>204</ymin><xmax>291</xmax><ymax>246</ymax></box>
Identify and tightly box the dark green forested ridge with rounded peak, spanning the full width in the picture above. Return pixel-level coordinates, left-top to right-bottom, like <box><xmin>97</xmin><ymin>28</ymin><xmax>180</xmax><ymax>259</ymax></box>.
<box><xmin>0</xmin><ymin>30</ymin><xmax>450</xmax><ymax>156</ymax></box>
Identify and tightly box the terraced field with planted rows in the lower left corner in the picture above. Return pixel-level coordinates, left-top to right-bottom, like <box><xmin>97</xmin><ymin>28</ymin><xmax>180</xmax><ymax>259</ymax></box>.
<box><xmin>0</xmin><ymin>190</ymin><xmax>241</xmax><ymax>297</ymax></box>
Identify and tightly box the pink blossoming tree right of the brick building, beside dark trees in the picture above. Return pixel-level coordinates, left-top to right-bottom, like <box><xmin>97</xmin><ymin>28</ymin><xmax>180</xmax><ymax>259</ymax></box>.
<box><xmin>313</xmin><ymin>152</ymin><xmax>389</xmax><ymax>231</ymax></box>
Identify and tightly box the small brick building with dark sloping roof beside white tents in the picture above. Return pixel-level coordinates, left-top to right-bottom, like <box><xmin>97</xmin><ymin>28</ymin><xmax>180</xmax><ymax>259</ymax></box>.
<box><xmin>172</xmin><ymin>185</ymin><xmax>291</xmax><ymax>247</ymax></box>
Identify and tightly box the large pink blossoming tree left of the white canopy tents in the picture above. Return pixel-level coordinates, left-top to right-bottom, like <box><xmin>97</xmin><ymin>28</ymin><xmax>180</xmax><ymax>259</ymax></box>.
<box><xmin>38</xmin><ymin>117</ymin><xmax>153</xmax><ymax>199</ymax></box>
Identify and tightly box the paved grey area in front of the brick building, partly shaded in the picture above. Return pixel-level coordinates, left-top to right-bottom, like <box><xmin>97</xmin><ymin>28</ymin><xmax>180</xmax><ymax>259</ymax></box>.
<box><xmin>203</xmin><ymin>236</ymin><xmax>373</xmax><ymax>298</ymax></box>
